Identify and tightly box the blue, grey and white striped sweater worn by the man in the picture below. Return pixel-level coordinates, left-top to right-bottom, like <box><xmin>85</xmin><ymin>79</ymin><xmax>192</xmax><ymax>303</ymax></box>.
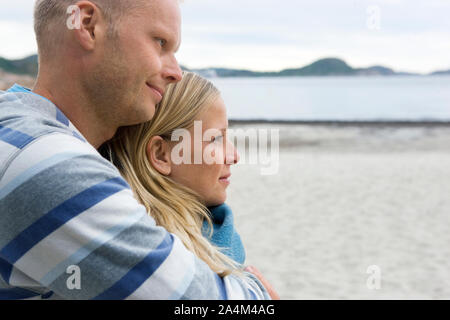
<box><xmin>0</xmin><ymin>85</ymin><xmax>270</xmax><ymax>299</ymax></box>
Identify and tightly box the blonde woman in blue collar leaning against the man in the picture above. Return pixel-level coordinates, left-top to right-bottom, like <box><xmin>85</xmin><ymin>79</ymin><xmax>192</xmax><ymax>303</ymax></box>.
<box><xmin>103</xmin><ymin>72</ymin><xmax>245</xmax><ymax>276</ymax></box>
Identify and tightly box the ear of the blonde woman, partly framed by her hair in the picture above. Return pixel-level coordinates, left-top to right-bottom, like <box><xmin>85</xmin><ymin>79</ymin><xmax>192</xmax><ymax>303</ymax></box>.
<box><xmin>146</xmin><ymin>136</ymin><xmax>172</xmax><ymax>176</ymax></box>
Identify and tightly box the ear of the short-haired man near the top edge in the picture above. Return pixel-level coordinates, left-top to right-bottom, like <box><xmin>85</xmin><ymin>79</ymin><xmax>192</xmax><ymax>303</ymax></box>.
<box><xmin>68</xmin><ymin>1</ymin><xmax>108</xmax><ymax>51</ymax></box>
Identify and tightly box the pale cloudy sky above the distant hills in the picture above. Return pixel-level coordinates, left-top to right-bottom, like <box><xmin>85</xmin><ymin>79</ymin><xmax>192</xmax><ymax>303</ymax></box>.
<box><xmin>0</xmin><ymin>0</ymin><xmax>450</xmax><ymax>73</ymax></box>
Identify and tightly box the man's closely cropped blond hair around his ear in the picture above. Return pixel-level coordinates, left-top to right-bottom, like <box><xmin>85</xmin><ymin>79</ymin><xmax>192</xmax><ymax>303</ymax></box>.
<box><xmin>34</xmin><ymin>0</ymin><xmax>148</xmax><ymax>56</ymax></box>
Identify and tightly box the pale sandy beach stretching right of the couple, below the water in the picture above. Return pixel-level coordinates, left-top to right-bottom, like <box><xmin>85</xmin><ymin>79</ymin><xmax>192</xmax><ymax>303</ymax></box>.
<box><xmin>227</xmin><ymin>122</ymin><xmax>450</xmax><ymax>299</ymax></box>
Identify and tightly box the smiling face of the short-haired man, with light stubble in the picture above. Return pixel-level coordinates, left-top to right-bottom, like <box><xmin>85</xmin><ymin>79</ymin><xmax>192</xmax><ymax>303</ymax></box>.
<box><xmin>88</xmin><ymin>0</ymin><xmax>182</xmax><ymax>126</ymax></box>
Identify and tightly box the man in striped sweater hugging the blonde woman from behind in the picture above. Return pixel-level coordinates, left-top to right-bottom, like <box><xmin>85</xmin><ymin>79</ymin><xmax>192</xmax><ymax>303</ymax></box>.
<box><xmin>0</xmin><ymin>0</ymin><xmax>269</xmax><ymax>299</ymax></box>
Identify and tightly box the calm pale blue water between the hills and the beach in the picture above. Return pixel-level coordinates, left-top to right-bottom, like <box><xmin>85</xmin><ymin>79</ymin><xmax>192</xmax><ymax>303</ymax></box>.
<box><xmin>211</xmin><ymin>76</ymin><xmax>450</xmax><ymax>121</ymax></box>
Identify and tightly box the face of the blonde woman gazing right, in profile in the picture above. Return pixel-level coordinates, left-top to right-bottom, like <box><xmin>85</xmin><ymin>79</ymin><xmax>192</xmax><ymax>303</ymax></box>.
<box><xmin>168</xmin><ymin>97</ymin><xmax>239</xmax><ymax>206</ymax></box>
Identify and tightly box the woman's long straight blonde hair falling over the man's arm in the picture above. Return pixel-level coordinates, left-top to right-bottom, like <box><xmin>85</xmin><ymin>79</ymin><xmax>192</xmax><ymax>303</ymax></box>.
<box><xmin>106</xmin><ymin>72</ymin><xmax>240</xmax><ymax>276</ymax></box>
